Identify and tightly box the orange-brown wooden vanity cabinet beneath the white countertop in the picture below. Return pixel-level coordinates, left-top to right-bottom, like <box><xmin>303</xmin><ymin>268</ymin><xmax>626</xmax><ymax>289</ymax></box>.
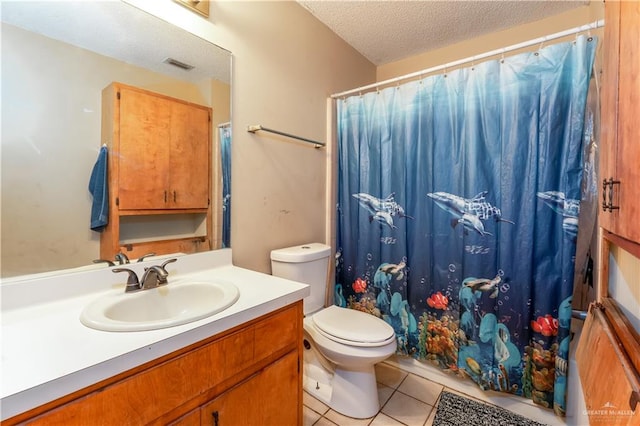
<box><xmin>3</xmin><ymin>301</ymin><xmax>302</xmax><ymax>426</ymax></box>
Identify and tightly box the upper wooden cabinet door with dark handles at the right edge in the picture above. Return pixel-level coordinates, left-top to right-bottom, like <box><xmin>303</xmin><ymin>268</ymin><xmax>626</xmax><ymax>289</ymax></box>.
<box><xmin>600</xmin><ymin>1</ymin><xmax>640</xmax><ymax>241</ymax></box>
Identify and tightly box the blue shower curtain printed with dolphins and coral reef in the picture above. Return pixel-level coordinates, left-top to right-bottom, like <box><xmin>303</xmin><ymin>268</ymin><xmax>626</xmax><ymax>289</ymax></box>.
<box><xmin>335</xmin><ymin>36</ymin><xmax>596</xmax><ymax>415</ymax></box>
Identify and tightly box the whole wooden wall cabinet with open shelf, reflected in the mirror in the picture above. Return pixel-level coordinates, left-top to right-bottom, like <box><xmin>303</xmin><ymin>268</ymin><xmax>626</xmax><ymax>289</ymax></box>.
<box><xmin>100</xmin><ymin>83</ymin><xmax>213</xmax><ymax>259</ymax></box>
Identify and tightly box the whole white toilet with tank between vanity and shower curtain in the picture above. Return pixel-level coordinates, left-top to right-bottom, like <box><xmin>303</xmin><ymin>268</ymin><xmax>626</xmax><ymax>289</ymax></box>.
<box><xmin>271</xmin><ymin>243</ymin><xmax>396</xmax><ymax>418</ymax></box>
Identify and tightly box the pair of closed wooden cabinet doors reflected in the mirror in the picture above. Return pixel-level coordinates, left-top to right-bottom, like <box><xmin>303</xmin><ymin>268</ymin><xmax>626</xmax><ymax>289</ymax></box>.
<box><xmin>117</xmin><ymin>87</ymin><xmax>211</xmax><ymax>210</ymax></box>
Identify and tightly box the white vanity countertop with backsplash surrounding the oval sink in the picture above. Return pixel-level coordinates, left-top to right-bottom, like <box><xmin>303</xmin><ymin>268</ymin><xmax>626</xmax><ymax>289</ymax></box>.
<box><xmin>0</xmin><ymin>249</ymin><xmax>309</xmax><ymax>420</ymax></box>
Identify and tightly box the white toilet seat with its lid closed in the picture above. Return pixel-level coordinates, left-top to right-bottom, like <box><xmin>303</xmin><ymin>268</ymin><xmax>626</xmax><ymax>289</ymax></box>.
<box><xmin>311</xmin><ymin>305</ymin><xmax>396</xmax><ymax>347</ymax></box>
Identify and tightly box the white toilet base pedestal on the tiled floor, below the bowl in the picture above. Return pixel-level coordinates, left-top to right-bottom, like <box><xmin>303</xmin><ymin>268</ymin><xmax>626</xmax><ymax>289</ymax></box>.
<box><xmin>303</xmin><ymin>342</ymin><xmax>380</xmax><ymax>419</ymax></box>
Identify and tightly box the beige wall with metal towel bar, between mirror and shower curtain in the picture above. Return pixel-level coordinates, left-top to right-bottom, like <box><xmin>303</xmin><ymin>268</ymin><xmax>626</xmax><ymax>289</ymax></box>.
<box><xmin>128</xmin><ymin>0</ymin><xmax>375</xmax><ymax>273</ymax></box>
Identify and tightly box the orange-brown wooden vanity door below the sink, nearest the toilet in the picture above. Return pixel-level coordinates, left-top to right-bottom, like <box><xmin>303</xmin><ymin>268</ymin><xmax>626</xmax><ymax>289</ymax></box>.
<box><xmin>201</xmin><ymin>351</ymin><xmax>302</xmax><ymax>426</ymax></box>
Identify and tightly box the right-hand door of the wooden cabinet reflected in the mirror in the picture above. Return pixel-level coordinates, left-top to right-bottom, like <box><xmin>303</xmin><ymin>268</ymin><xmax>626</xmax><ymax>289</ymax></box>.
<box><xmin>169</xmin><ymin>102</ymin><xmax>211</xmax><ymax>209</ymax></box>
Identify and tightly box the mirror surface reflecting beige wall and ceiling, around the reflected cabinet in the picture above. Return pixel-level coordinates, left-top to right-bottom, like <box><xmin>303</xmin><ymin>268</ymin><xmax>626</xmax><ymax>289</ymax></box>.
<box><xmin>0</xmin><ymin>1</ymin><xmax>231</xmax><ymax>278</ymax></box>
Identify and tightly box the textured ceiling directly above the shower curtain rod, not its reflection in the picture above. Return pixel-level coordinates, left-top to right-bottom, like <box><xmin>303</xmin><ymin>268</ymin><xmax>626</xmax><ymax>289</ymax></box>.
<box><xmin>298</xmin><ymin>0</ymin><xmax>589</xmax><ymax>65</ymax></box>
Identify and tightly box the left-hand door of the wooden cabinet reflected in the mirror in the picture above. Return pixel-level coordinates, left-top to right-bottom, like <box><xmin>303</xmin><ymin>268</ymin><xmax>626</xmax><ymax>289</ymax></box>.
<box><xmin>119</xmin><ymin>87</ymin><xmax>171</xmax><ymax>210</ymax></box>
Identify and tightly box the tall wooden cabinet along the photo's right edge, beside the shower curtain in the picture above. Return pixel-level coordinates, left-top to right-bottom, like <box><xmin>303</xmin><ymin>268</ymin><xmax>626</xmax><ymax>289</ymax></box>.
<box><xmin>576</xmin><ymin>0</ymin><xmax>640</xmax><ymax>426</ymax></box>
